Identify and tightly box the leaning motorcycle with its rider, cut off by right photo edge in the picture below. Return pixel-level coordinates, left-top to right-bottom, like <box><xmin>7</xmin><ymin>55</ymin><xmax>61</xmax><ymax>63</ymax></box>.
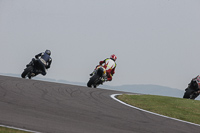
<box><xmin>183</xmin><ymin>75</ymin><xmax>200</xmax><ymax>100</ymax></box>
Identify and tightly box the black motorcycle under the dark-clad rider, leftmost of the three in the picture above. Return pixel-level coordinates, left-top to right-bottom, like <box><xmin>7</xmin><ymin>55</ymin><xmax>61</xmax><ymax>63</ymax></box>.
<box><xmin>21</xmin><ymin>58</ymin><xmax>41</xmax><ymax>79</ymax></box>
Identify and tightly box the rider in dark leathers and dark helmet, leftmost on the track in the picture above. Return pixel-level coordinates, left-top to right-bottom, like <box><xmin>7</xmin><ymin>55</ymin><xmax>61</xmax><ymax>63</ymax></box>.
<box><xmin>27</xmin><ymin>50</ymin><xmax>52</xmax><ymax>79</ymax></box>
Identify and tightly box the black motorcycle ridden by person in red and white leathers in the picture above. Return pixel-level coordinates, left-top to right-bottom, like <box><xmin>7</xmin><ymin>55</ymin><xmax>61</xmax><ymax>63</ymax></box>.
<box><xmin>87</xmin><ymin>66</ymin><xmax>107</xmax><ymax>88</ymax></box>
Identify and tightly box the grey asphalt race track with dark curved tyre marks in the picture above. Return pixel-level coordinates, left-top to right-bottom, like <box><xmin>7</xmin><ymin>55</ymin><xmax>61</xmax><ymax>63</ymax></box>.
<box><xmin>0</xmin><ymin>76</ymin><xmax>200</xmax><ymax>133</ymax></box>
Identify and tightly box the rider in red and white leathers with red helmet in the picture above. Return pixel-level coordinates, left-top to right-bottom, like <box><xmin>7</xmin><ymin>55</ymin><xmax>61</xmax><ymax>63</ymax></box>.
<box><xmin>90</xmin><ymin>54</ymin><xmax>117</xmax><ymax>83</ymax></box>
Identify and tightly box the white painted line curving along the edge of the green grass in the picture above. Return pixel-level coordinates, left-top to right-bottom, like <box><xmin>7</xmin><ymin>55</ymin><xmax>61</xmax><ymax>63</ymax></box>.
<box><xmin>110</xmin><ymin>94</ymin><xmax>200</xmax><ymax>126</ymax></box>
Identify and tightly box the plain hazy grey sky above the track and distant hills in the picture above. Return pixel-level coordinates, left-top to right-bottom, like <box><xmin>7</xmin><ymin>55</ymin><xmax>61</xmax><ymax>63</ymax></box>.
<box><xmin>0</xmin><ymin>0</ymin><xmax>200</xmax><ymax>90</ymax></box>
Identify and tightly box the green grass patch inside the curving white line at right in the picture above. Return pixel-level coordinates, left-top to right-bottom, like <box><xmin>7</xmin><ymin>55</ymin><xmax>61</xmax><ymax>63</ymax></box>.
<box><xmin>117</xmin><ymin>95</ymin><xmax>200</xmax><ymax>124</ymax></box>
